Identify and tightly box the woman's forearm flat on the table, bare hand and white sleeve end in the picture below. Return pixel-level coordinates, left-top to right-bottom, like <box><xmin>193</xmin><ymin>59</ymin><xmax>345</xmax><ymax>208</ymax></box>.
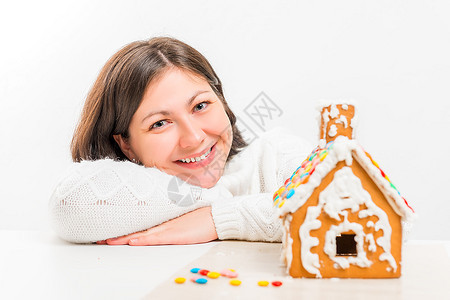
<box><xmin>102</xmin><ymin>194</ymin><xmax>282</xmax><ymax>246</ymax></box>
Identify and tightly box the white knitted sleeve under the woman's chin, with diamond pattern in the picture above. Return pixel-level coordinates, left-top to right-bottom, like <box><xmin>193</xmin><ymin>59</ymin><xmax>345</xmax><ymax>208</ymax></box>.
<box><xmin>48</xmin><ymin>159</ymin><xmax>230</xmax><ymax>243</ymax></box>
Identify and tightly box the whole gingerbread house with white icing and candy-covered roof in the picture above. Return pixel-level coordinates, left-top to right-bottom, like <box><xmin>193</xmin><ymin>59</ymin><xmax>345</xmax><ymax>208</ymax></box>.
<box><xmin>274</xmin><ymin>103</ymin><xmax>414</xmax><ymax>278</ymax></box>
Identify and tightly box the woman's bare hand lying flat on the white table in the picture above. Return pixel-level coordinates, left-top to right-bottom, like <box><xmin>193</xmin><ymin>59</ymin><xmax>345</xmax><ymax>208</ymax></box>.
<box><xmin>97</xmin><ymin>206</ymin><xmax>217</xmax><ymax>246</ymax></box>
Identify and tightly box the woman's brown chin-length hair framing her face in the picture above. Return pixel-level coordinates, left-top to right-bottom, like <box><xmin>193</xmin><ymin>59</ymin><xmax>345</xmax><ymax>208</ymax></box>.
<box><xmin>70</xmin><ymin>37</ymin><xmax>247</xmax><ymax>162</ymax></box>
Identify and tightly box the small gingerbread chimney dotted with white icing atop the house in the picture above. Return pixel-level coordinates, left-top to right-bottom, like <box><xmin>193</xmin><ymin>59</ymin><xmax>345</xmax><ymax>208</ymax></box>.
<box><xmin>320</xmin><ymin>104</ymin><xmax>355</xmax><ymax>143</ymax></box>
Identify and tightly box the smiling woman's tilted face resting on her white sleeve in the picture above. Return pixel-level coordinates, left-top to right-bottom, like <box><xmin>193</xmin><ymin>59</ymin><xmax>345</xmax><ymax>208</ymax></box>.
<box><xmin>115</xmin><ymin>68</ymin><xmax>233</xmax><ymax>188</ymax></box>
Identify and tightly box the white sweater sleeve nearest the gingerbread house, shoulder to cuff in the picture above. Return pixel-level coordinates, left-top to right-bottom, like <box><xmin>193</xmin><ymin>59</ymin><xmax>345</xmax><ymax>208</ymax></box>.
<box><xmin>211</xmin><ymin>129</ymin><xmax>312</xmax><ymax>242</ymax></box>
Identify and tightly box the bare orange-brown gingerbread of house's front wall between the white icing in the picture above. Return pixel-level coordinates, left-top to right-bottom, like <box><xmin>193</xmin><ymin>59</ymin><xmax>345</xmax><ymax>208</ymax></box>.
<box><xmin>289</xmin><ymin>159</ymin><xmax>402</xmax><ymax>278</ymax></box>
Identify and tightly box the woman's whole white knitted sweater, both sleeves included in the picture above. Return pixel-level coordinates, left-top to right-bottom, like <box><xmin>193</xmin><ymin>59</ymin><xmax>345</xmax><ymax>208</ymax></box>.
<box><xmin>49</xmin><ymin>129</ymin><xmax>312</xmax><ymax>243</ymax></box>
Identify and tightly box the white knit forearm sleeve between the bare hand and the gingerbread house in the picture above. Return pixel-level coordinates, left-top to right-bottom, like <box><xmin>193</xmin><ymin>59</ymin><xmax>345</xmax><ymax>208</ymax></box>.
<box><xmin>211</xmin><ymin>193</ymin><xmax>282</xmax><ymax>242</ymax></box>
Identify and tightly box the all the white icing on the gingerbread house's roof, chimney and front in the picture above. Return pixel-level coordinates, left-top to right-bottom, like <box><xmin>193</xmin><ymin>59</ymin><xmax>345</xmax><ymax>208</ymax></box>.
<box><xmin>273</xmin><ymin>102</ymin><xmax>415</xmax><ymax>277</ymax></box>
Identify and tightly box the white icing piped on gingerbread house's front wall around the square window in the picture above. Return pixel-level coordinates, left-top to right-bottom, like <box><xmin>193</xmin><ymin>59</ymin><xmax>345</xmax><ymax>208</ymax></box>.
<box><xmin>299</xmin><ymin>167</ymin><xmax>397</xmax><ymax>277</ymax></box>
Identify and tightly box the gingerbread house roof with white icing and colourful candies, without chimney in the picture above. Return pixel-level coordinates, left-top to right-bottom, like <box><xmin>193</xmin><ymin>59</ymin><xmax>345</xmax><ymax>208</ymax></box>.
<box><xmin>273</xmin><ymin>136</ymin><xmax>414</xmax><ymax>220</ymax></box>
